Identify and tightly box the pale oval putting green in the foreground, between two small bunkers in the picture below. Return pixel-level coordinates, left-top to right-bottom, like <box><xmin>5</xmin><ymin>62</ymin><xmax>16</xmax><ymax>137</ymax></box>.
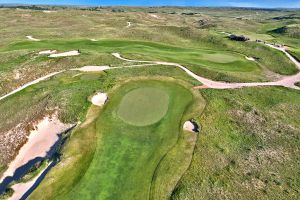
<box><xmin>117</xmin><ymin>87</ymin><xmax>169</xmax><ymax>126</ymax></box>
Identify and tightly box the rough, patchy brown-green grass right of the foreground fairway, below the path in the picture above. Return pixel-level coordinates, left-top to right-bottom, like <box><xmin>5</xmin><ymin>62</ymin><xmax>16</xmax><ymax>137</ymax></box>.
<box><xmin>171</xmin><ymin>87</ymin><xmax>300</xmax><ymax>199</ymax></box>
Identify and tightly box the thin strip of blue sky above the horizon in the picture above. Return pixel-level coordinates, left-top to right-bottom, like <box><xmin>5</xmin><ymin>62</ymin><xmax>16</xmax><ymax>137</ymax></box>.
<box><xmin>0</xmin><ymin>0</ymin><xmax>300</xmax><ymax>8</ymax></box>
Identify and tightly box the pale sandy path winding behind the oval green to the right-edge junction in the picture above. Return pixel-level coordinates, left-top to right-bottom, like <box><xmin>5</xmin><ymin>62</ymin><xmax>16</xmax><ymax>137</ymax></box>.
<box><xmin>112</xmin><ymin>44</ymin><xmax>300</xmax><ymax>90</ymax></box>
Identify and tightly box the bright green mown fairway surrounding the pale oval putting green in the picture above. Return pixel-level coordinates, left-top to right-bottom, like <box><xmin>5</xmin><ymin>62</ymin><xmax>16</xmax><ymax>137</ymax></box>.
<box><xmin>32</xmin><ymin>80</ymin><xmax>203</xmax><ymax>199</ymax></box>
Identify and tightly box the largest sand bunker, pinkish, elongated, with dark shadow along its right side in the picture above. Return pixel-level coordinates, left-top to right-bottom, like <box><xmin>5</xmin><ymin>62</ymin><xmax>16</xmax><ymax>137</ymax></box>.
<box><xmin>0</xmin><ymin>114</ymin><xmax>72</xmax><ymax>182</ymax></box>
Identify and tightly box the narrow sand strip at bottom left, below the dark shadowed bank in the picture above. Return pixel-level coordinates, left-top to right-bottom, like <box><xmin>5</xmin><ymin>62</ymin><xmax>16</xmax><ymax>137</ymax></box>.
<box><xmin>8</xmin><ymin>162</ymin><xmax>51</xmax><ymax>200</ymax></box>
